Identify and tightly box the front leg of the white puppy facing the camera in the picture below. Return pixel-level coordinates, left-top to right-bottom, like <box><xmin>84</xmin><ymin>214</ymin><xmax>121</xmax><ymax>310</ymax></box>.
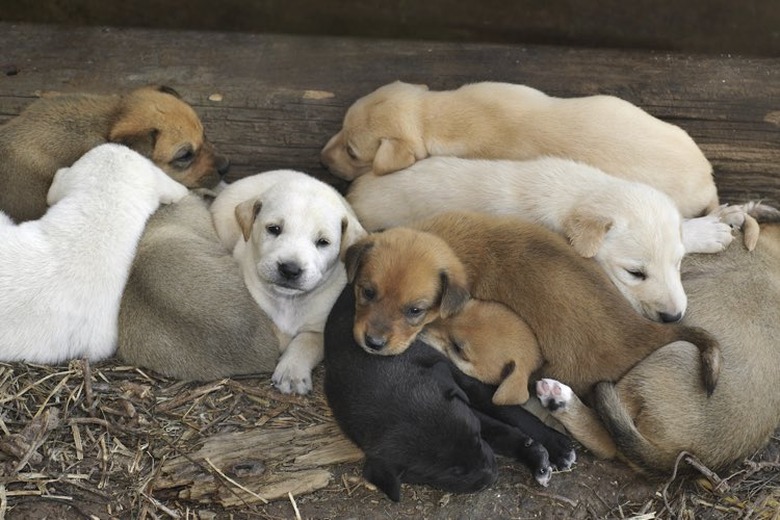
<box><xmin>271</xmin><ymin>332</ymin><xmax>324</xmax><ymax>394</ymax></box>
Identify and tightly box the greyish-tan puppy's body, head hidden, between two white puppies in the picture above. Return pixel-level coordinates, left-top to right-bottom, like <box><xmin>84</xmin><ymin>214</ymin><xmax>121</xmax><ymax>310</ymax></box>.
<box><xmin>117</xmin><ymin>192</ymin><xmax>279</xmax><ymax>380</ymax></box>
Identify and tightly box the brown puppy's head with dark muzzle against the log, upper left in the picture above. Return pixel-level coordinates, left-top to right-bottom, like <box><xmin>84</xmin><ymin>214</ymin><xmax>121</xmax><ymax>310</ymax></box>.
<box><xmin>109</xmin><ymin>87</ymin><xmax>230</xmax><ymax>188</ymax></box>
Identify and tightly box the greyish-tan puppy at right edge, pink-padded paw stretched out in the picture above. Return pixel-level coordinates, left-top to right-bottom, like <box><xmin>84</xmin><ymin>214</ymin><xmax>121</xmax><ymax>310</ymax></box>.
<box><xmin>537</xmin><ymin>214</ymin><xmax>780</xmax><ymax>472</ymax></box>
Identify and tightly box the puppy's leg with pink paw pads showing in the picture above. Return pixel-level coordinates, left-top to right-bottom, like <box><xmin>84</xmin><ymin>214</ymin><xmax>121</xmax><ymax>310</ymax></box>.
<box><xmin>536</xmin><ymin>379</ymin><xmax>617</xmax><ymax>459</ymax></box>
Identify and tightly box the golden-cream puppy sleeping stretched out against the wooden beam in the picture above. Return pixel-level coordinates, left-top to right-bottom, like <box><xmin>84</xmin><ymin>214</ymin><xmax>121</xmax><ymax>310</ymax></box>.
<box><xmin>321</xmin><ymin>81</ymin><xmax>718</xmax><ymax>218</ymax></box>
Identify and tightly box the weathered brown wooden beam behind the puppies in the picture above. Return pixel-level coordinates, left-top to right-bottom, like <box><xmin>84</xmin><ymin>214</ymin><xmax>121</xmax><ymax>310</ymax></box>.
<box><xmin>0</xmin><ymin>24</ymin><xmax>780</xmax><ymax>204</ymax></box>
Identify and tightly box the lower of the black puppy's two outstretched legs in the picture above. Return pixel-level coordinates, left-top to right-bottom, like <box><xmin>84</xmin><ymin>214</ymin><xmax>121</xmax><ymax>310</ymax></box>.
<box><xmin>472</xmin><ymin>409</ymin><xmax>552</xmax><ymax>487</ymax></box>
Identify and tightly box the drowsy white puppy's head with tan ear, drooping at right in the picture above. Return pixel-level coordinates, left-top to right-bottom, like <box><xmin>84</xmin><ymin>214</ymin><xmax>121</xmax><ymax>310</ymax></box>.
<box><xmin>564</xmin><ymin>193</ymin><xmax>688</xmax><ymax>322</ymax></box>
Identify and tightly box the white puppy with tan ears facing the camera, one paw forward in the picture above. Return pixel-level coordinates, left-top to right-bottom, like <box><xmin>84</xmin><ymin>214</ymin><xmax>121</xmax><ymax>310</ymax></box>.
<box><xmin>211</xmin><ymin>170</ymin><xmax>366</xmax><ymax>394</ymax></box>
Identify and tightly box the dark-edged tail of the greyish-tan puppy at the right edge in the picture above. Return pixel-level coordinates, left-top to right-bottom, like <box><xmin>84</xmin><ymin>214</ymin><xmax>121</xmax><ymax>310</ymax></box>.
<box><xmin>593</xmin><ymin>381</ymin><xmax>675</xmax><ymax>472</ymax></box>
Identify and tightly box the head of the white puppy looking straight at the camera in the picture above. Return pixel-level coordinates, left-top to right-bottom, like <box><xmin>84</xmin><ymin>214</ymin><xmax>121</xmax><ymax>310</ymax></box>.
<box><xmin>235</xmin><ymin>175</ymin><xmax>366</xmax><ymax>295</ymax></box>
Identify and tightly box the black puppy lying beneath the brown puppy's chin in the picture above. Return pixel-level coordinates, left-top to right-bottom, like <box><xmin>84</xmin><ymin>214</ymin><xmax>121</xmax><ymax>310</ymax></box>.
<box><xmin>325</xmin><ymin>287</ymin><xmax>573</xmax><ymax>501</ymax></box>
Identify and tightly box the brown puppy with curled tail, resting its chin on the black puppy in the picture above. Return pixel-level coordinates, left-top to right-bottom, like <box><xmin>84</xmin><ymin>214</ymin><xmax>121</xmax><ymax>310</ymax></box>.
<box><xmin>346</xmin><ymin>213</ymin><xmax>720</xmax><ymax>394</ymax></box>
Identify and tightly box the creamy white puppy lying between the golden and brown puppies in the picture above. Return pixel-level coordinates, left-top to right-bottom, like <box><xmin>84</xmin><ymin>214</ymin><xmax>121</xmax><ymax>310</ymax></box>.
<box><xmin>347</xmin><ymin>157</ymin><xmax>744</xmax><ymax>321</ymax></box>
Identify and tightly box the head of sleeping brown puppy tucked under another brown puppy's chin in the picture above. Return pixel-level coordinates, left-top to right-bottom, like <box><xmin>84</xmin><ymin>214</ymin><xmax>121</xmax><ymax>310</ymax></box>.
<box><xmin>420</xmin><ymin>300</ymin><xmax>542</xmax><ymax>405</ymax></box>
